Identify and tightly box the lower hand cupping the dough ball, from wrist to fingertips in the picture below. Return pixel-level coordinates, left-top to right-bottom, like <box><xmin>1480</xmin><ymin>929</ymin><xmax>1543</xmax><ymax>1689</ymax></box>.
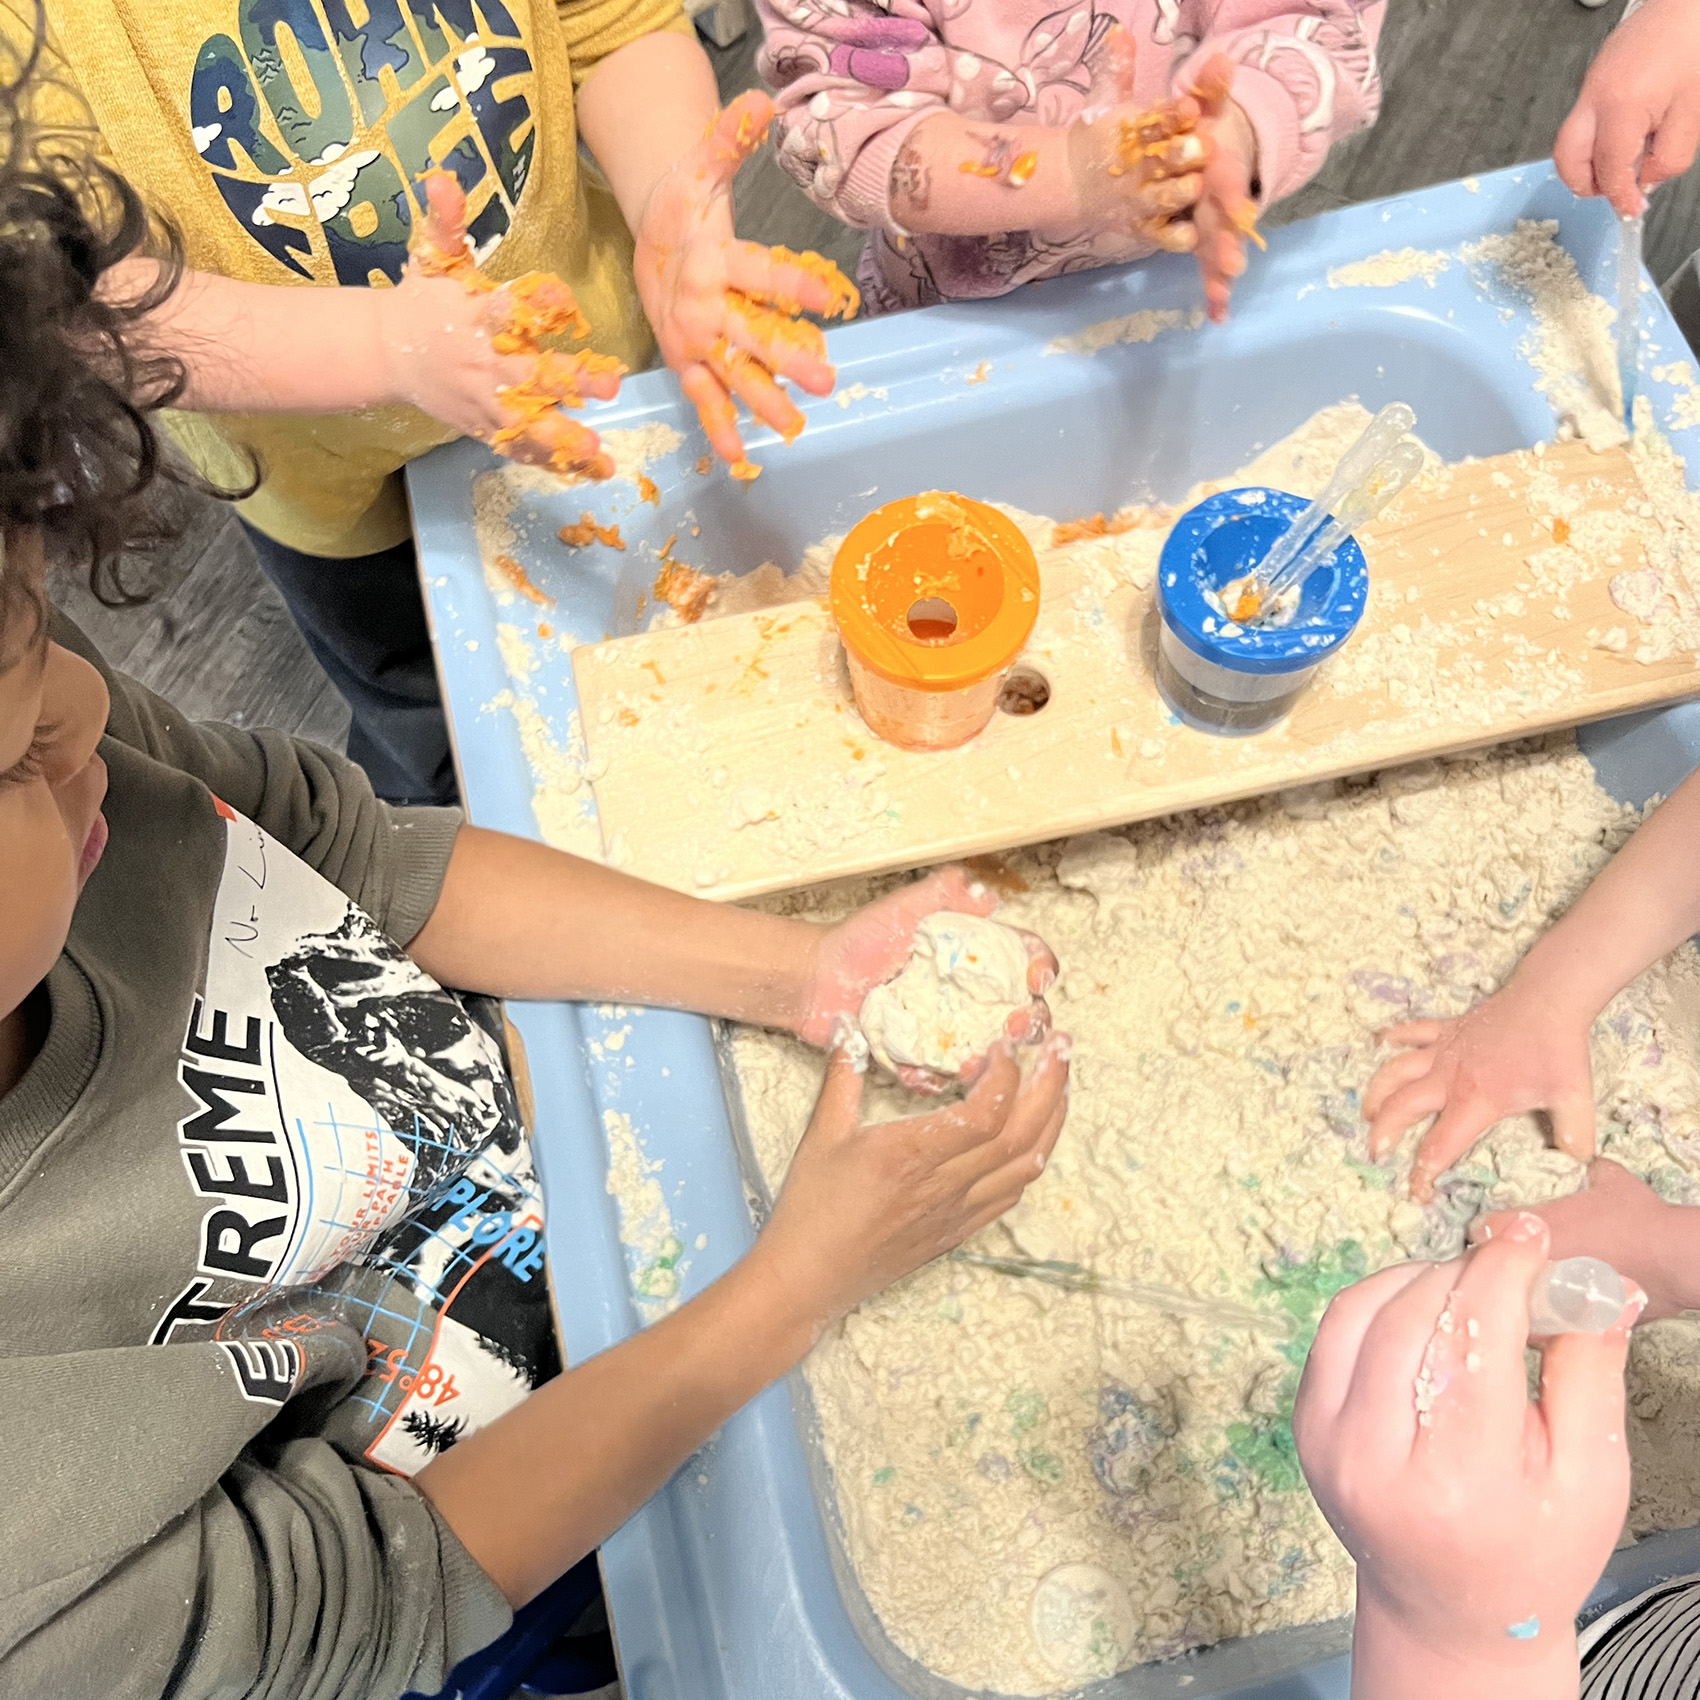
<box><xmin>751</xmin><ymin>1034</ymin><xmax>1068</xmax><ymax>1328</ymax></box>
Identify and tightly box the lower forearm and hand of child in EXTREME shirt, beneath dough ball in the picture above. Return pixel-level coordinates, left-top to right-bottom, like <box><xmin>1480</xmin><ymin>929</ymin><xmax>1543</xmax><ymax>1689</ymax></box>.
<box><xmin>415</xmin><ymin>1039</ymin><xmax>1068</xmax><ymax>1605</ymax></box>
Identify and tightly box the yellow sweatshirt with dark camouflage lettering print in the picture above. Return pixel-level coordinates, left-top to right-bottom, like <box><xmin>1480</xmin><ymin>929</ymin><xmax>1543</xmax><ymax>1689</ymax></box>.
<box><xmin>14</xmin><ymin>0</ymin><xmax>690</xmax><ymax>558</ymax></box>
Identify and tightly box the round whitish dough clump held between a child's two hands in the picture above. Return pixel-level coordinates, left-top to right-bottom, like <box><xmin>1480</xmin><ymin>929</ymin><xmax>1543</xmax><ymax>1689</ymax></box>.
<box><xmin>862</xmin><ymin>911</ymin><xmax>1029</xmax><ymax>1074</ymax></box>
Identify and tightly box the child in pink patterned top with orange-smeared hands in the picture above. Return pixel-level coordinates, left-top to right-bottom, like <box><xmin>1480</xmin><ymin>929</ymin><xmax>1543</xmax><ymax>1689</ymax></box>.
<box><xmin>758</xmin><ymin>0</ymin><xmax>1386</xmax><ymax>320</ymax></box>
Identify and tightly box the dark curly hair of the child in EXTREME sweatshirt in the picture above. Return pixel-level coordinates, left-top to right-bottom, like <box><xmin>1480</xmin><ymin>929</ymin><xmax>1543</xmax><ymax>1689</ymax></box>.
<box><xmin>0</xmin><ymin>0</ymin><xmax>227</xmax><ymax>648</ymax></box>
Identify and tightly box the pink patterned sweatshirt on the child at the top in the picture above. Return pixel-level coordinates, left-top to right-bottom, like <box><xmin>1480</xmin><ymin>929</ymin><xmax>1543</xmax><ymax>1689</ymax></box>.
<box><xmin>757</xmin><ymin>0</ymin><xmax>1386</xmax><ymax>313</ymax></box>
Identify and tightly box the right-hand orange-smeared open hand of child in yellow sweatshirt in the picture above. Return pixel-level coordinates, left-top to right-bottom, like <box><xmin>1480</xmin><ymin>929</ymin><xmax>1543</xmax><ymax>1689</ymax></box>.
<box><xmin>634</xmin><ymin>90</ymin><xmax>860</xmax><ymax>478</ymax></box>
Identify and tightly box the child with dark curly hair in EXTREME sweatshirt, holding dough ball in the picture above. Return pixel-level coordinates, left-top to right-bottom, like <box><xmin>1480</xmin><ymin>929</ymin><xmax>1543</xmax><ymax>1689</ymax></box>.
<box><xmin>0</xmin><ymin>19</ymin><xmax>1068</xmax><ymax>1700</ymax></box>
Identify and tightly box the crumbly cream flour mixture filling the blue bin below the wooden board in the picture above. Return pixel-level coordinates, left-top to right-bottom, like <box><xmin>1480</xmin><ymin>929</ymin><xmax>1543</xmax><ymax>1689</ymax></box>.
<box><xmin>733</xmin><ymin>751</ymin><xmax>1700</xmax><ymax>1693</ymax></box>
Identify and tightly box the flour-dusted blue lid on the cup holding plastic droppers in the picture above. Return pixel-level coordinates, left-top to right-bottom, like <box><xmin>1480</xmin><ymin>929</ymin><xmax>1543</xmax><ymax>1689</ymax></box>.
<box><xmin>1158</xmin><ymin>486</ymin><xmax>1370</xmax><ymax>673</ymax></box>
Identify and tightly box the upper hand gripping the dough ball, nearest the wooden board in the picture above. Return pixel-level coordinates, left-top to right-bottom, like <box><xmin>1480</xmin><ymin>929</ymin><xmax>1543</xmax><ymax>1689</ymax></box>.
<box><xmin>797</xmin><ymin>867</ymin><xmax>1057</xmax><ymax>1091</ymax></box>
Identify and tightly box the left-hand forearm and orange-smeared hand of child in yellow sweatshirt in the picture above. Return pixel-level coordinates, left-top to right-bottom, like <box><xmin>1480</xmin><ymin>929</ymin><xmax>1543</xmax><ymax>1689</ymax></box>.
<box><xmin>121</xmin><ymin>173</ymin><xmax>619</xmax><ymax>476</ymax></box>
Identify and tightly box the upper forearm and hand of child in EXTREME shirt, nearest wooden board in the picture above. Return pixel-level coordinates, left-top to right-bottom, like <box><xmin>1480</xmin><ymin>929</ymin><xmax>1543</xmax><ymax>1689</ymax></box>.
<box><xmin>408</xmin><ymin>826</ymin><xmax>1056</xmax><ymax>1067</ymax></box>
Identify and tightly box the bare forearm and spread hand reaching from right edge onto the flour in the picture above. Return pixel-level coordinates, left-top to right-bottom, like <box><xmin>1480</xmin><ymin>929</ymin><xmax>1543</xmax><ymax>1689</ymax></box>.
<box><xmin>1363</xmin><ymin>770</ymin><xmax>1700</xmax><ymax>1199</ymax></box>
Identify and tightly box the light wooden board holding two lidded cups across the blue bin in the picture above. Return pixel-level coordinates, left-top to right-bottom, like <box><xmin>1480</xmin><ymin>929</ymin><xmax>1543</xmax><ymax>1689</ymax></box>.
<box><xmin>573</xmin><ymin>444</ymin><xmax>1700</xmax><ymax>898</ymax></box>
